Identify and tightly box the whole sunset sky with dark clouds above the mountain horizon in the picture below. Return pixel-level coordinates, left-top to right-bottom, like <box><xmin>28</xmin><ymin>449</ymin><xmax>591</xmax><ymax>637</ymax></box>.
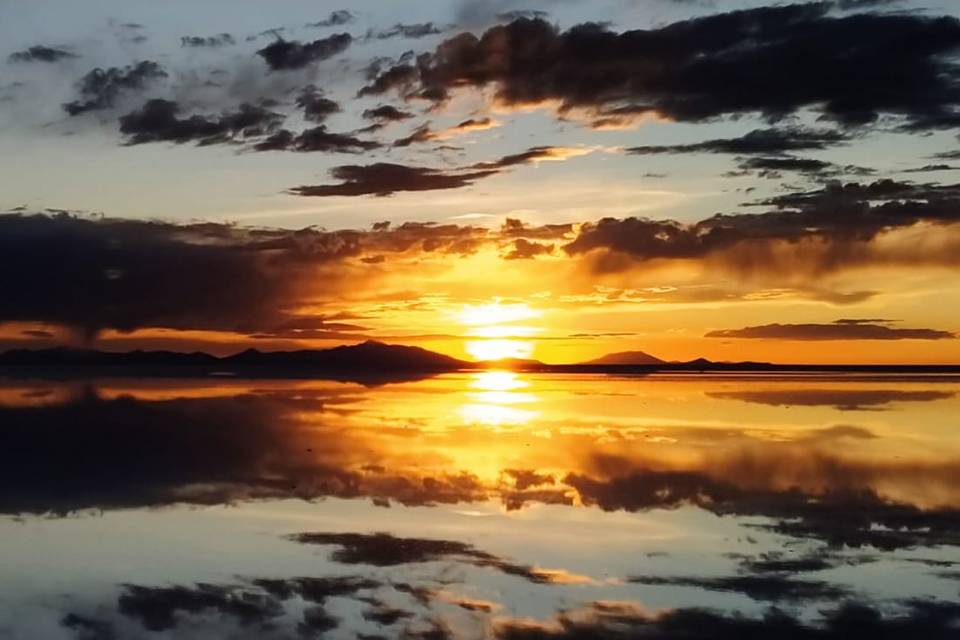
<box><xmin>0</xmin><ymin>0</ymin><xmax>960</xmax><ymax>363</ymax></box>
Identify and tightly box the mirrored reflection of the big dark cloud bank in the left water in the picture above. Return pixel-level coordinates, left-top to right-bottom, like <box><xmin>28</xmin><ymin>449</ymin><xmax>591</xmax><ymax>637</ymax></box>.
<box><xmin>0</xmin><ymin>383</ymin><xmax>491</xmax><ymax>515</ymax></box>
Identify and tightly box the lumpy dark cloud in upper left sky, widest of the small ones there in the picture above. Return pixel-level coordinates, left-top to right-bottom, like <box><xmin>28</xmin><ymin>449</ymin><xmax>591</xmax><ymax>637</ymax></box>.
<box><xmin>120</xmin><ymin>98</ymin><xmax>284</xmax><ymax>145</ymax></box>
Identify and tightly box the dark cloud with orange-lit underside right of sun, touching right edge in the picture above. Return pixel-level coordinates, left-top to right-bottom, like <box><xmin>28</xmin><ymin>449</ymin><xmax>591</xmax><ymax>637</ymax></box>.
<box><xmin>563</xmin><ymin>179</ymin><xmax>960</xmax><ymax>275</ymax></box>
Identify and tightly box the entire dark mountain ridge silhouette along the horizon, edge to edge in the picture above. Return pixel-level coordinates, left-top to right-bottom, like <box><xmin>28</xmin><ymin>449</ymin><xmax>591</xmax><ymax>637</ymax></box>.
<box><xmin>0</xmin><ymin>340</ymin><xmax>960</xmax><ymax>383</ymax></box>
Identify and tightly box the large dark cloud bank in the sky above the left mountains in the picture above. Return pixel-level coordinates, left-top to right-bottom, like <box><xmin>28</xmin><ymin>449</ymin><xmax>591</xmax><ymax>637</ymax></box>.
<box><xmin>0</xmin><ymin>214</ymin><xmax>484</xmax><ymax>335</ymax></box>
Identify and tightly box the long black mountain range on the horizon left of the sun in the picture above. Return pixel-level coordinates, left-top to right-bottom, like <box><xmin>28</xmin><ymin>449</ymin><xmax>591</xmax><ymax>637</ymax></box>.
<box><xmin>0</xmin><ymin>340</ymin><xmax>471</xmax><ymax>374</ymax></box>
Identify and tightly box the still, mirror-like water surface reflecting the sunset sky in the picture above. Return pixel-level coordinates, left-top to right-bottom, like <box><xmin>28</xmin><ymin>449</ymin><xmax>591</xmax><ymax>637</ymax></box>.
<box><xmin>0</xmin><ymin>372</ymin><xmax>960</xmax><ymax>640</ymax></box>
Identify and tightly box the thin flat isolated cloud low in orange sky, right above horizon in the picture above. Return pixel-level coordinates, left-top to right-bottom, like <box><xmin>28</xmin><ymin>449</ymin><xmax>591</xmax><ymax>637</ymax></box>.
<box><xmin>706</xmin><ymin>320</ymin><xmax>956</xmax><ymax>340</ymax></box>
